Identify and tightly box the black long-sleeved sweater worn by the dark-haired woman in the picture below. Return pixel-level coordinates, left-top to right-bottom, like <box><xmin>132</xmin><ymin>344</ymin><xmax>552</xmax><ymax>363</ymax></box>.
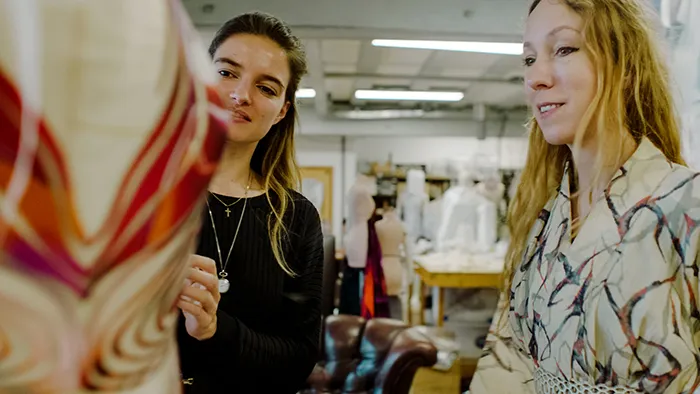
<box><xmin>178</xmin><ymin>189</ymin><xmax>323</xmax><ymax>394</ymax></box>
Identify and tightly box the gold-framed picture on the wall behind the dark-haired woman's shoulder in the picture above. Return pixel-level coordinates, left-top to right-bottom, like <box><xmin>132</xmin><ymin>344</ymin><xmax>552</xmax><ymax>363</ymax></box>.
<box><xmin>301</xmin><ymin>167</ymin><xmax>333</xmax><ymax>228</ymax></box>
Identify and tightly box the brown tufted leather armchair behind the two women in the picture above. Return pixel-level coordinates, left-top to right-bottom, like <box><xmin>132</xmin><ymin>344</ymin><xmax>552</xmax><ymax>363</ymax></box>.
<box><xmin>302</xmin><ymin>315</ymin><xmax>437</xmax><ymax>394</ymax></box>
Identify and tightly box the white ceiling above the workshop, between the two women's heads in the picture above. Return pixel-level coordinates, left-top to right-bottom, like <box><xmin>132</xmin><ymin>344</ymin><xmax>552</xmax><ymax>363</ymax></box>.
<box><xmin>183</xmin><ymin>0</ymin><xmax>530</xmax><ymax>115</ymax></box>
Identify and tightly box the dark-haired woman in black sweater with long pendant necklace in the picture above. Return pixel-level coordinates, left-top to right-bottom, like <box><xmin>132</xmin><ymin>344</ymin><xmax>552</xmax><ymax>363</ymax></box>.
<box><xmin>178</xmin><ymin>13</ymin><xmax>323</xmax><ymax>394</ymax></box>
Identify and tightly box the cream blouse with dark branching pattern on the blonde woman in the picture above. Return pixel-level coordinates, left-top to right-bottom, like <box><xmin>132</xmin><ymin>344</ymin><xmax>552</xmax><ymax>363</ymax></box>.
<box><xmin>470</xmin><ymin>139</ymin><xmax>700</xmax><ymax>394</ymax></box>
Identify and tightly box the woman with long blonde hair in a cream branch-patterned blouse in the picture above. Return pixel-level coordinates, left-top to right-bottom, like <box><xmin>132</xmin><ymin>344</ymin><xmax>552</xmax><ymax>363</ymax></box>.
<box><xmin>471</xmin><ymin>0</ymin><xmax>700</xmax><ymax>394</ymax></box>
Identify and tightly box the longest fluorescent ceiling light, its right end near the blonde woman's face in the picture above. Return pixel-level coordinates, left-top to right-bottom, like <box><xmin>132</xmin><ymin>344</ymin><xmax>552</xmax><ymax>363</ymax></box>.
<box><xmin>372</xmin><ymin>40</ymin><xmax>523</xmax><ymax>55</ymax></box>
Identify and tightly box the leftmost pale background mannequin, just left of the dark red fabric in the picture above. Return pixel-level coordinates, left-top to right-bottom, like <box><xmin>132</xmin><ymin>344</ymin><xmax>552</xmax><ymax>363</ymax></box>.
<box><xmin>345</xmin><ymin>175</ymin><xmax>375</xmax><ymax>268</ymax></box>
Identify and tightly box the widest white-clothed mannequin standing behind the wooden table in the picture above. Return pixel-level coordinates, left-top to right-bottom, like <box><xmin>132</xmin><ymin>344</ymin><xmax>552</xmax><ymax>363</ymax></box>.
<box><xmin>436</xmin><ymin>171</ymin><xmax>498</xmax><ymax>252</ymax></box>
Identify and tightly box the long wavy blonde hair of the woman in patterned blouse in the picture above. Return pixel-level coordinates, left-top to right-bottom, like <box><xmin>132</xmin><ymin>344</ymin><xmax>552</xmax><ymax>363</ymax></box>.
<box><xmin>499</xmin><ymin>0</ymin><xmax>685</xmax><ymax>323</ymax></box>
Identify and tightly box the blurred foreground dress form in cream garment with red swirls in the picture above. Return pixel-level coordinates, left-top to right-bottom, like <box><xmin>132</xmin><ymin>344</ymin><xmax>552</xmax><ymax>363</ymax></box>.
<box><xmin>0</xmin><ymin>0</ymin><xmax>226</xmax><ymax>394</ymax></box>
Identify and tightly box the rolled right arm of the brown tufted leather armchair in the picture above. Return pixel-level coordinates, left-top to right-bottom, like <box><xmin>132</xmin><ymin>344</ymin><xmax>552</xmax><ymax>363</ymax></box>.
<box><xmin>374</xmin><ymin>328</ymin><xmax>438</xmax><ymax>394</ymax></box>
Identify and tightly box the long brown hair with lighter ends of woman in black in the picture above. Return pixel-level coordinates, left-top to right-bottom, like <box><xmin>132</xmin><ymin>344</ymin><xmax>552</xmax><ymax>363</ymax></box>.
<box><xmin>209</xmin><ymin>12</ymin><xmax>307</xmax><ymax>276</ymax></box>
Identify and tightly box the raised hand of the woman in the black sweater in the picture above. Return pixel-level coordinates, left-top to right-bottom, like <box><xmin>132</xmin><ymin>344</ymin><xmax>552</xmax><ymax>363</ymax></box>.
<box><xmin>177</xmin><ymin>255</ymin><xmax>221</xmax><ymax>341</ymax></box>
